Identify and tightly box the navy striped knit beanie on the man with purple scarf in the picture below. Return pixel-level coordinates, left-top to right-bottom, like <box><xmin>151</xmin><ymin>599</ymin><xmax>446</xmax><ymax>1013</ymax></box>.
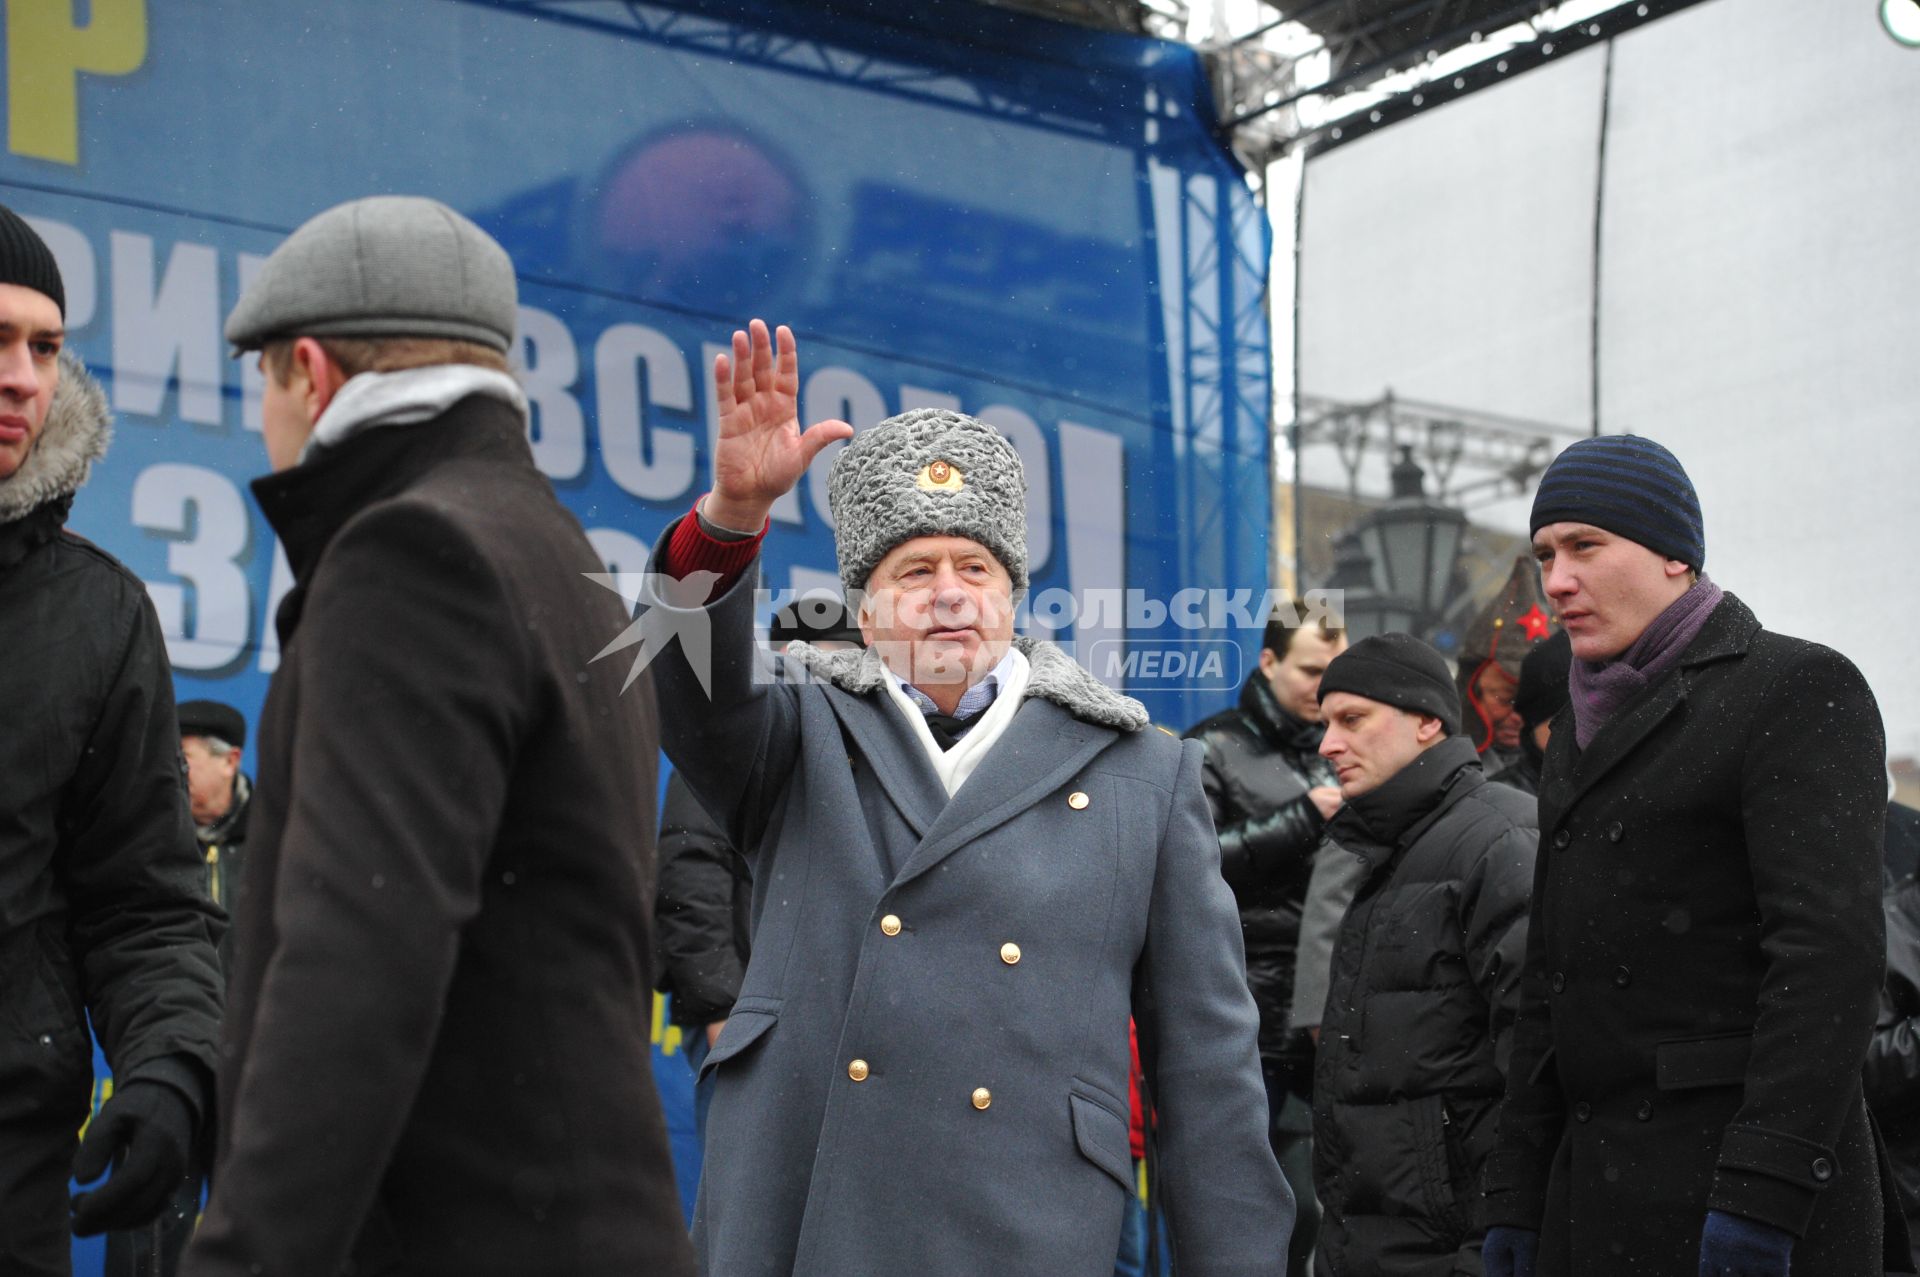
<box><xmin>1526</xmin><ymin>434</ymin><xmax>1707</xmax><ymax>572</ymax></box>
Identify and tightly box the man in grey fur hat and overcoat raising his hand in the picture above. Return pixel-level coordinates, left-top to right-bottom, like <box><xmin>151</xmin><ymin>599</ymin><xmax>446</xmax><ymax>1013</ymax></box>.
<box><xmin>643</xmin><ymin>321</ymin><xmax>1294</xmax><ymax>1277</ymax></box>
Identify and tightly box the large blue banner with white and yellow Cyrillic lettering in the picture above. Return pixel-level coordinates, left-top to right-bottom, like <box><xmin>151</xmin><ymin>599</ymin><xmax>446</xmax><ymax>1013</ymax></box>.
<box><xmin>0</xmin><ymin>0</ymin><xmax>1269</xmax><ymax>1252</ymax></box>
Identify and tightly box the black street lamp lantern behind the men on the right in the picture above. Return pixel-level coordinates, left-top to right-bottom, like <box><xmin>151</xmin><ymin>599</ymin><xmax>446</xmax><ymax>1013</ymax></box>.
<box><xmin>1327</xmin><ymin>446</ymin><xmax>1467</xmax><ymax>639</ymax></box>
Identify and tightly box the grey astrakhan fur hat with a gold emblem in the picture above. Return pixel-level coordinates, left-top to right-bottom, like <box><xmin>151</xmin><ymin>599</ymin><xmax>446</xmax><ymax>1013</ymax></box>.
<box><xmin>828</xmin><ymin>407</ymin><xmax>1027</xmax><ymax>597</ymax></box>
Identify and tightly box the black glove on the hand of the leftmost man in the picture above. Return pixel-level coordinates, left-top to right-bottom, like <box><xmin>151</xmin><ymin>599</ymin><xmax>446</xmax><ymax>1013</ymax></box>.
<box><xmin>73</xmin><ymin>1079</ymin><xmax>194</xmax><ymax>1237</ymax></box>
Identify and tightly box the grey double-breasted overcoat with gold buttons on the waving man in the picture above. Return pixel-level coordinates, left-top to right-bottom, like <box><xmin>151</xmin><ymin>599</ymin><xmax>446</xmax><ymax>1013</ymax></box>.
<box><xmin>645</xmin><ymin>549</ymin><xmax>1294</xmax><ymax>1277</ymax></box>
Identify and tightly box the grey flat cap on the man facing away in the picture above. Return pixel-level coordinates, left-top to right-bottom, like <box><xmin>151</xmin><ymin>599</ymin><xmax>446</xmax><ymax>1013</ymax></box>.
<box><xmin>227</xmin><ymin>196</ymin><xmax>518</xmax><ymax>353</ymax></box>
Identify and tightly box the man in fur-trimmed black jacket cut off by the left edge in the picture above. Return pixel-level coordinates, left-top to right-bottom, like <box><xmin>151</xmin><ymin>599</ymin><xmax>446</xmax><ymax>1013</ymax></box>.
<box><xmin>0</xmin><ymin>207</ymin><xmax>225</xmax><ymax>1277</ymax></box>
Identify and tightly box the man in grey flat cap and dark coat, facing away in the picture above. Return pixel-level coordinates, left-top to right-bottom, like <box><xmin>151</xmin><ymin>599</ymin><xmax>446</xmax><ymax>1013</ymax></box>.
<box><xmin>184</xmin><ymin>198</ymin><xmax>693</xmax><ymax>1277</ymax></box>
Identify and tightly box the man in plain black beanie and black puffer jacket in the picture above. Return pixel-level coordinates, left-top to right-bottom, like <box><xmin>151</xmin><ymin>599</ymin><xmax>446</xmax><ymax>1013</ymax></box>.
<box><xmin>1313</xmin><ymin>634</ymin><xmax>1540</xmax><ymax>1277</ymax></box>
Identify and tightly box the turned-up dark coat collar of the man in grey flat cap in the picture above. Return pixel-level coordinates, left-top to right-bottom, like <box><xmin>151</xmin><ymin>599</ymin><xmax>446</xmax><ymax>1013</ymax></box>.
<box><xmin>253</xmin><ymin>396</ymin><xmax>532</xmax><ymax>643</ymax></box>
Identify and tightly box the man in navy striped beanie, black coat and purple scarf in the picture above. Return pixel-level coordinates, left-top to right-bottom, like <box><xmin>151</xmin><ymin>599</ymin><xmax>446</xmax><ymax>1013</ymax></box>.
<box><xmin>1482</xmin><ymin>436</ymin><xmax>1907</xmax><ymax>1277</ymax></box>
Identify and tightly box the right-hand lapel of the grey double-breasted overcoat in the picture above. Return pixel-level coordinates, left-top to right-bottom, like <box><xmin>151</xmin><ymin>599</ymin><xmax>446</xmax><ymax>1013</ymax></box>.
<box><xmin>895</xmin><ymin>699</ymin><xmax>1117</xmax><ymax>885</ymax></box>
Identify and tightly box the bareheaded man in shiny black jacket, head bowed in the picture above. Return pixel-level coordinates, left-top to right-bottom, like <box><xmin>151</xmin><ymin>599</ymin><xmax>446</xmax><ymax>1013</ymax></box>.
<box><xmin>1187</xmin><ymin>616</ymin><xmax>1346</xmax><ymax>1271</ymax></box>
